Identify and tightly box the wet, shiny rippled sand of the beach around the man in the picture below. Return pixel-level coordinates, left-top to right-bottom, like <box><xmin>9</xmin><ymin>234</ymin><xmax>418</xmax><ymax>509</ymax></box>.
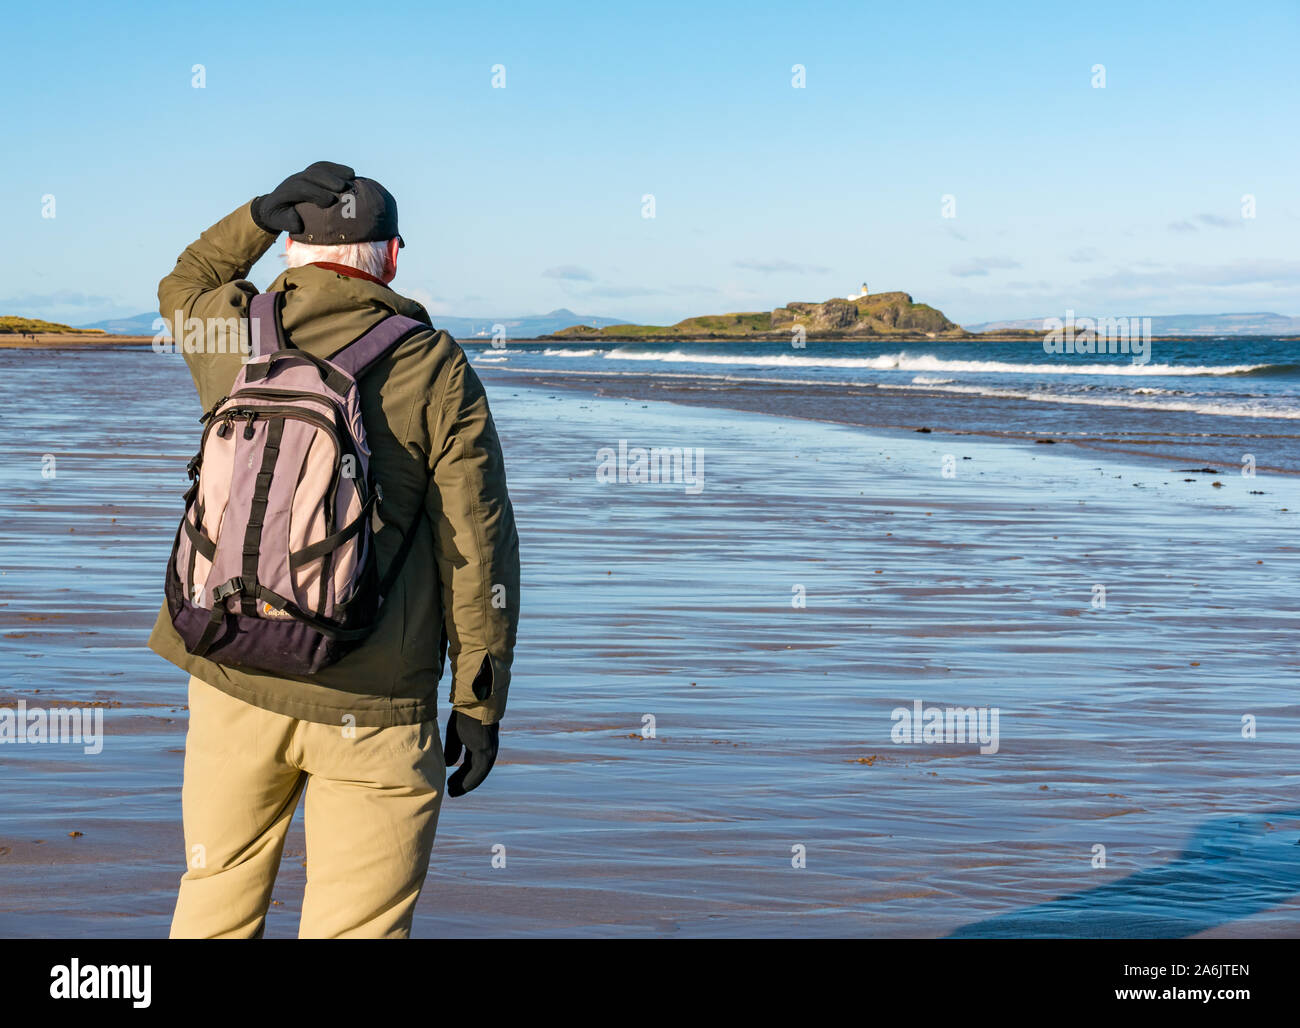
<box><xmin>0</xmin><ymin>351</ymin><xmax>1300</xmax><ymax>937</ymax></box>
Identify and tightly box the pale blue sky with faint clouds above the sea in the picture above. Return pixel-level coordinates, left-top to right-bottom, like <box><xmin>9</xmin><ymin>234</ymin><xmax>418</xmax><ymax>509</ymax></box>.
<box><xmin>0</xmin><ymin>0</ymin><xmax>1300</xmax><ymax>324</ymax></box>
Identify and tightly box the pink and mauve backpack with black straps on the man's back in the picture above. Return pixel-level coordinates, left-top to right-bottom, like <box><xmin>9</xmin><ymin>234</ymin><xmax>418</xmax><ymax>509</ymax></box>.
<box><xmin>165</xmin><ymin>292</ymin><xmax>428</xmax><ymax>676</ymax></box>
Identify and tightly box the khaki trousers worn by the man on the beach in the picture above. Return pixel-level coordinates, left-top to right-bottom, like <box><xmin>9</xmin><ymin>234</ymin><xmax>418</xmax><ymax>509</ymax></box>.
<box><xmin>172</xmin><ymin>677</ymin><xmax>447</xmax><ymax>938</ymax></box>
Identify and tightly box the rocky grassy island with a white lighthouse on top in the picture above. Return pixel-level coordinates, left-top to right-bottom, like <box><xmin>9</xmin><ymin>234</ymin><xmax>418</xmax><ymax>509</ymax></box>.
<box><xmin>555</xmin><ymin>292</ymin><xmax>966</xmax><ymax>339</ymax></box>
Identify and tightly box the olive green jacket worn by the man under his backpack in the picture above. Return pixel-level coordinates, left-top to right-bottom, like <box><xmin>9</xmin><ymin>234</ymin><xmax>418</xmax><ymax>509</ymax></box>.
<box><xmin>150</xmin><ymin>204</ymin><xmax>519</xmax><ymax>728</ymax></box>
